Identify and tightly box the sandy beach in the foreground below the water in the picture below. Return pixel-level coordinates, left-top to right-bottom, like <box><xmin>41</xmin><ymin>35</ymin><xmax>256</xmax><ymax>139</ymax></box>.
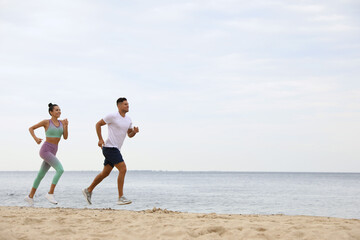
<box><xmin>0</xmin><ymin>207</ymin><xmax>360</xmax><ymax>240</ymax></box>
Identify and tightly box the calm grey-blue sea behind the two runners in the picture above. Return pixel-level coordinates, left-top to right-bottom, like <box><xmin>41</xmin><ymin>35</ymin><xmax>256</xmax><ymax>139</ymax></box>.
<box><xmin>0</xmin><ymin>170</ymin><xmax>360</xmax><ymax>219</ymax></box>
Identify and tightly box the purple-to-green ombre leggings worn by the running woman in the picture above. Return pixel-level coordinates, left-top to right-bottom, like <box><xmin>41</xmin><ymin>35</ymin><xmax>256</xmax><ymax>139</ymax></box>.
<box><xmin>33</xmin><ymin>142</ymin><xmax>64</xmax><ymax>189</ymax></box>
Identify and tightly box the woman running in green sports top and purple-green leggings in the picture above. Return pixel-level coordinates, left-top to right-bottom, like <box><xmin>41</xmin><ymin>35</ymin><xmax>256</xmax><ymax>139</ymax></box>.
<box><xmin>25</xmin><ymin>103</ymin><xmax>69</xmax><ymax>206</ymax></box>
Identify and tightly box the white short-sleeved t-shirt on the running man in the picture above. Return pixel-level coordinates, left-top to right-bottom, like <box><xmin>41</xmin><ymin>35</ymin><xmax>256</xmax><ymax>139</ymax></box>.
<box><xmin>103</xmin><ymin>112</ymin><xmax>132</xmax><ymax>150</ymax></box>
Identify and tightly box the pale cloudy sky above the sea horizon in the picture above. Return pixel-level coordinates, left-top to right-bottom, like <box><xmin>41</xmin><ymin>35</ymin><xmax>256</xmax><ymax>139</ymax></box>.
<box><xmin>0</xmin><ymin>0</ymin><xmax>360</xmax><ymax>172</ymax></box>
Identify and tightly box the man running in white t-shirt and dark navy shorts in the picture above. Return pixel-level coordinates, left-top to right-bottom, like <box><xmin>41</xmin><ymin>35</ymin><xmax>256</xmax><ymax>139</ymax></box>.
<box><xmin>82</xmin><ymin>98</ymin><xmax>139</xmax><ymax>205</ymax></box>
